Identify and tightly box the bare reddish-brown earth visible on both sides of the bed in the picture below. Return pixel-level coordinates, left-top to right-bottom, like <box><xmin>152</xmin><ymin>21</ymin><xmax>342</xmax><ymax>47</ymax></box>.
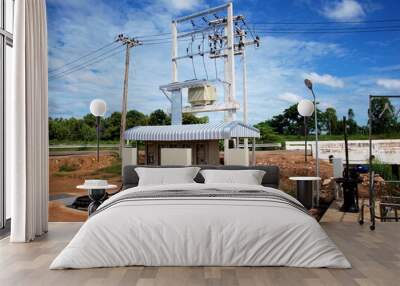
<box><xmin>49</xmin><ymin>151</ymin><xmax>333</xmax><ymax>221</ymax></box>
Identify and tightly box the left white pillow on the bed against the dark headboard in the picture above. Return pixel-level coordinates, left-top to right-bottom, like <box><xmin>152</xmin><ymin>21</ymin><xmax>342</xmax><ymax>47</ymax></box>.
<box><xmin>135</xmin><ymin>167</ymin><xmax>200</xmax><ymax>186</ymax></box>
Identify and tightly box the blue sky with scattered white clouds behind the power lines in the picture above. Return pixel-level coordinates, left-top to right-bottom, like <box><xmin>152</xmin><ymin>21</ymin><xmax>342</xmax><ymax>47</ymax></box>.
<box><xmin>47</xmin><ymin>0</ymin><xmax>400</xmax><ymax>124</ymax></box>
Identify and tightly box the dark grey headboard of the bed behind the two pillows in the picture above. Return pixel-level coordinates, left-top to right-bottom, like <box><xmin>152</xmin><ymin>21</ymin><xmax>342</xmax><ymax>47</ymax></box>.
<box><xmin>122</xmin><ymin>165</ymin><xmax>279</xmax><ymax>190</ymax></box>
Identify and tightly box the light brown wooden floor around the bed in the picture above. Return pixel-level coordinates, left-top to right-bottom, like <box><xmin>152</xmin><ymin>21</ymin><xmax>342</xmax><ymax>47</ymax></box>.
<box><xmin>0</xmin><ymin>218</ymin><xmax>400</xmax><ymax>286</ymax></box>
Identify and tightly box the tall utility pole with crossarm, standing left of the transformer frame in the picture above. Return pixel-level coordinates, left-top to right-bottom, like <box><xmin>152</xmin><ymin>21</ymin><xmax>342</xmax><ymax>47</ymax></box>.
<box><xmin>117</xmin><ymin>34</ymin><xmax>142</xmax><ymax>157</ymax></box>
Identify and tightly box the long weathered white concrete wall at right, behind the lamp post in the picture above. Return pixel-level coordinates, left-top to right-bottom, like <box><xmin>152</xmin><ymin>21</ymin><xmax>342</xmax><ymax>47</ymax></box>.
<box><xmin>286</xmin><ymin>139</ymin><xmax>400</xmax><ymax>164</ymax></box>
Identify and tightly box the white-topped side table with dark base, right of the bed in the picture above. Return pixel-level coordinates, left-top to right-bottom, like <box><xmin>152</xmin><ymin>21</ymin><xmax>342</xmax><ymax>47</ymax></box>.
<box><xmin>289</xmin><ymin>177</ymin><xmax>321</xmax><ymax>209</ymax></box>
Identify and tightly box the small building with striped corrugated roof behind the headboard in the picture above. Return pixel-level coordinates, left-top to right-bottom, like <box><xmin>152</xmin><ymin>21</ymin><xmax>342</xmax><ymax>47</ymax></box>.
<box><xmin>125</xmin><ymin>121</ymin><xmax>260</xmax><ymax>165</ymax></box>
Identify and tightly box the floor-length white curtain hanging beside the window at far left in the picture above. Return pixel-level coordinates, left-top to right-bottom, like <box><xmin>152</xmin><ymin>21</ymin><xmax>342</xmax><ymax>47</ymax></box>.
<box><xmin>6</xmin><ymin>0</ymin><xmax>49</xmax><ymax>242</ymax></box>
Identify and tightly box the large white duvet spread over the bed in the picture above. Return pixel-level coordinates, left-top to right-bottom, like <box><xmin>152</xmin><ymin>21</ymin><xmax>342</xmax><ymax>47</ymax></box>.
<box><xmin>50</xmin><ymin>184</ymin><xmax>350</xmax><ymax>269</ymax></box>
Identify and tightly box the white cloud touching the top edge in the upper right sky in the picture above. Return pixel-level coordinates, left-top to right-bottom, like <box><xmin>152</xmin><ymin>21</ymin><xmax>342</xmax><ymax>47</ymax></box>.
<box><xmin>322</xmin><ymin>0</ymin><xmax>365</xmax><ymax>21</ymax></box>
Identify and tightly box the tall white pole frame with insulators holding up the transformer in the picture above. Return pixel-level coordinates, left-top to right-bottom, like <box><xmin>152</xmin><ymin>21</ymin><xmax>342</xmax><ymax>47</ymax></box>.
<box><xmin>160</xmin><ymin>2</ymin><xmax>260</xmax><ymax>159</ymax></box>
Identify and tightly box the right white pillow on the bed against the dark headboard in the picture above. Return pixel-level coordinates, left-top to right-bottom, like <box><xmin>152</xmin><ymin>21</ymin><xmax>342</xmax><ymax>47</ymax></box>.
<box><xmin>200</xmin><ymin>170</ymin><xmax>265</xmax><ymax>185</ymax></box>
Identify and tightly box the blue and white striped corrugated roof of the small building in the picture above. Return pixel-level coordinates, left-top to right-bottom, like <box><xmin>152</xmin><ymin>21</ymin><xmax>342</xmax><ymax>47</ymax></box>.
<box><xmin>124</xmin><ymin>121</ymin><xmax>260</xmax><ymax>141</ymax></box>
